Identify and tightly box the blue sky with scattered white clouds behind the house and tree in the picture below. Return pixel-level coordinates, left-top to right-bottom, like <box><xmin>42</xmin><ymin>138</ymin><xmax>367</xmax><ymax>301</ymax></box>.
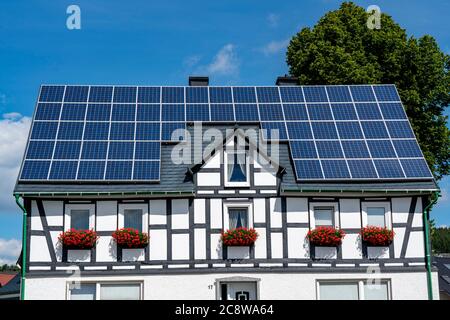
<box><xmin>0</xmin><ymin>0</ymin><xmax>450</xmax><ymax>262</ymax></box>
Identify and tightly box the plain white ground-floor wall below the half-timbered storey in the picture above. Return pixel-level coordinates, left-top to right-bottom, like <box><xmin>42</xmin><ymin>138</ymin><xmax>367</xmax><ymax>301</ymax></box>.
<box><xmin>25</xmin><ymin>272</ymin><xmax>439</xmax><ymax>300</ymax></box>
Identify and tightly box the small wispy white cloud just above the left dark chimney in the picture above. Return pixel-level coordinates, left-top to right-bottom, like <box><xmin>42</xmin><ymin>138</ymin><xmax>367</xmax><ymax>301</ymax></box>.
<box><xmin>197</xmin><ymin>43</ymin><xmax>239</xmax><ymax>76</ymax></box>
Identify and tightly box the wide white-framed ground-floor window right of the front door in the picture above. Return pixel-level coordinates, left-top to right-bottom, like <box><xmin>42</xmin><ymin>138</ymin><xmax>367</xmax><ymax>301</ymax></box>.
<box><xmin>317</xmin><ymin>279</ymin><xmax>390</xmax><ymax>300</ymax></box>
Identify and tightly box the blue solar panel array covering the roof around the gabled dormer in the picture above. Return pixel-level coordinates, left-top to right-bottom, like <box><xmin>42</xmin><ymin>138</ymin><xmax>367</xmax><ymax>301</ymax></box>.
<box><xmin>20</xmin><ymin>85</ymin><xmax>432</xmax><ymax>181</ymax></box>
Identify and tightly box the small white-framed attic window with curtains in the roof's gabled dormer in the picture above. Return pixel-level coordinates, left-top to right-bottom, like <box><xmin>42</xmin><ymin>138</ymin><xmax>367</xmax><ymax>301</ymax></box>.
<box><xmin>225</xmin><ymin>150</ymin><xmax>249</xmax><ymax>186</ymax></box>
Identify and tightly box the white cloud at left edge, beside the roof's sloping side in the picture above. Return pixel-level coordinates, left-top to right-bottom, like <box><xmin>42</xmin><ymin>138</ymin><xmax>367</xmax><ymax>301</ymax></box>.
<box><xmin>0</xmin><ymin>112</ymin><xmax>31</xmax><ymax>214</ymax></box>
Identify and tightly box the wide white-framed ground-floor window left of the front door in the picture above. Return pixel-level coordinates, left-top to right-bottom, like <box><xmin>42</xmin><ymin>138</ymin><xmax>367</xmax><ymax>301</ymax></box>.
<box><xmin>68</xmin><ymin>282</ymin><xmax>142</xmax><ymax>300</ymax></box>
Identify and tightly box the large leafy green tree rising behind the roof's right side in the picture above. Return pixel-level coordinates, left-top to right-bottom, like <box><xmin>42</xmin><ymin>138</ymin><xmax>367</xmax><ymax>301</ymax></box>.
<box><xmin>286</xmin><ymin>2</ymin><xmax>450</xmax><ymax>179</ymax></box>
